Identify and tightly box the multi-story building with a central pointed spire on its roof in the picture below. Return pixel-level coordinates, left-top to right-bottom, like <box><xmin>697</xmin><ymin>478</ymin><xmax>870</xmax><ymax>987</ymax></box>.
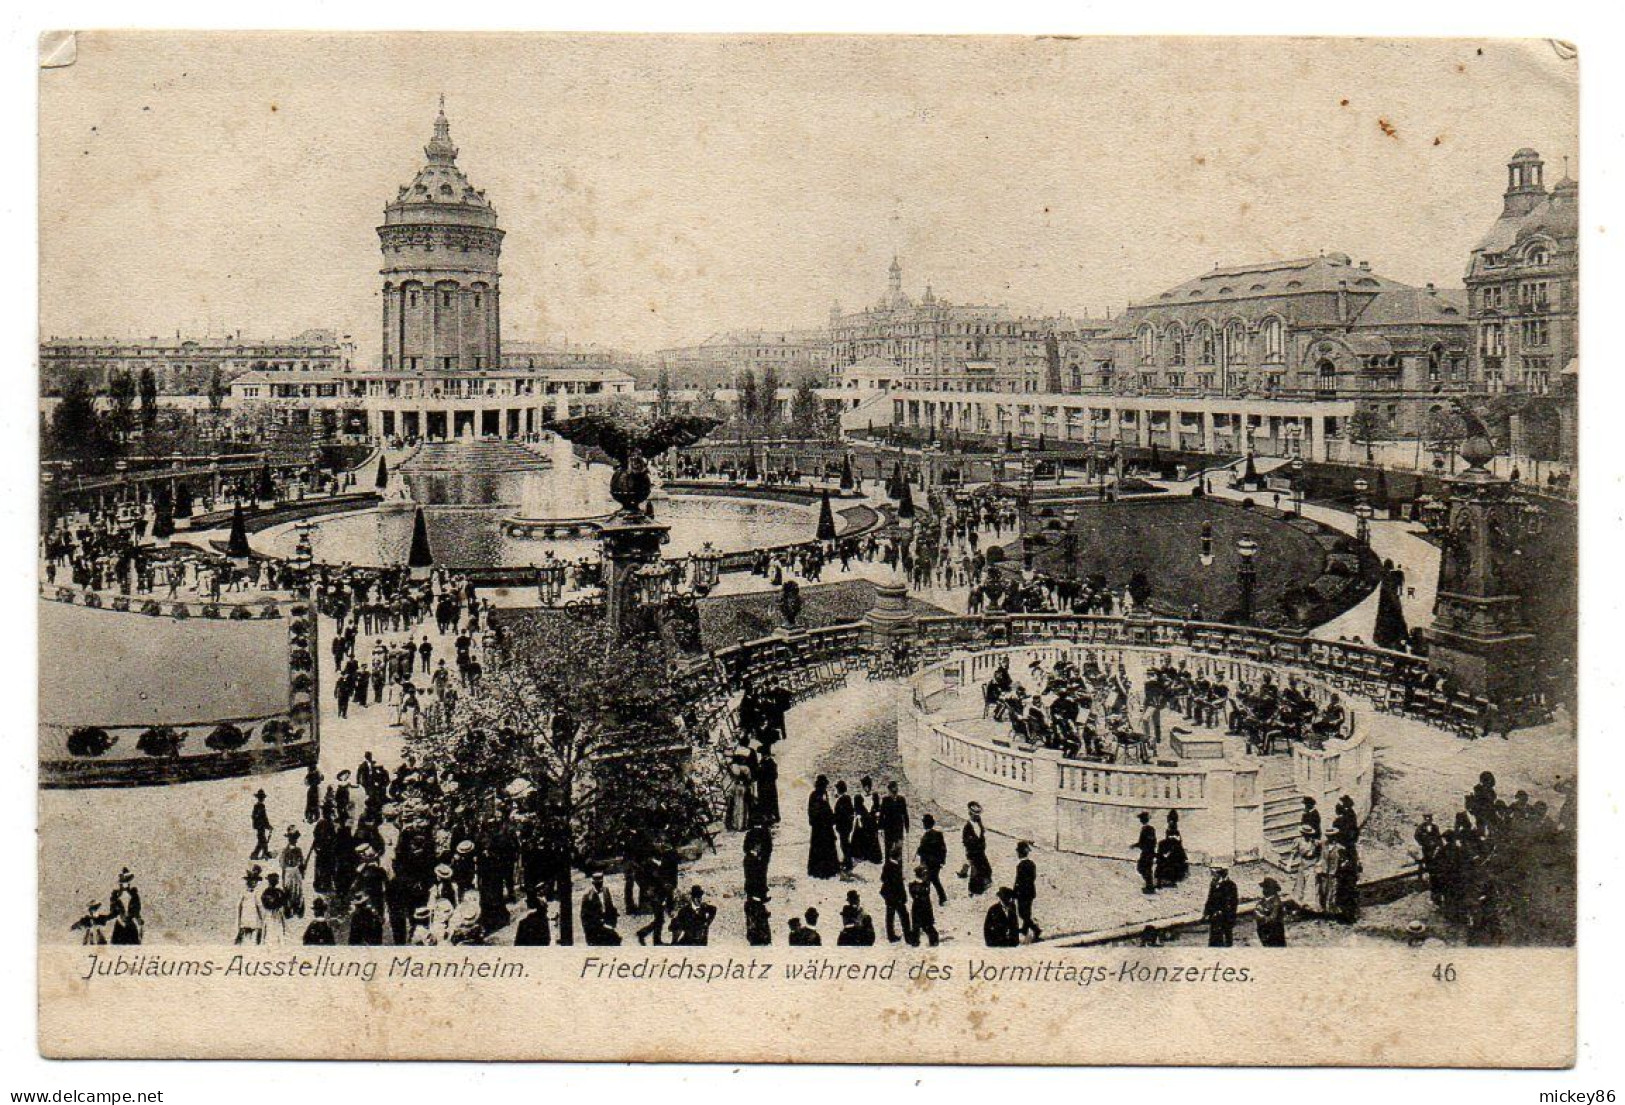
<box><xmin>829</xmin><ymin>257</ymin><xmax>1110</xmax><ymax>392</ymax></box>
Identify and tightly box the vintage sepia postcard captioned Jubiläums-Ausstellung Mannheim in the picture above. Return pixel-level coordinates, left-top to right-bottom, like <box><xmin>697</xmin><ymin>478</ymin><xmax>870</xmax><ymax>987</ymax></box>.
<box><xmin>37</xmin><ymin>31</ymin><xmax>1581</xmax><ymax>1068</ymax></box>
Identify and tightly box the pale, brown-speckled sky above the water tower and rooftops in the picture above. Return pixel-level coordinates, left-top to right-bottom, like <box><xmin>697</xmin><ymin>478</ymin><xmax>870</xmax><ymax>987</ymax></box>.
<box><xmin>39</xmin><ymin>33</ymin><xmax>1580</xmax><ymax>364</ymax></box>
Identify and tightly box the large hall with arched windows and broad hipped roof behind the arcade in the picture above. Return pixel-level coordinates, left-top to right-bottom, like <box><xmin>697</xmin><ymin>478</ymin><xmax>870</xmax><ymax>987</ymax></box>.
<box><xmin>1090</xmin><ymin>254</ymin><xmax>1471</xmax><ymax>436</ymax></box>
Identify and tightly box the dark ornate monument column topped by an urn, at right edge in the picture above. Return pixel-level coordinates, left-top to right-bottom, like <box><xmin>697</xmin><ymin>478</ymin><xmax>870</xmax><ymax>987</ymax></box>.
<box><xmin>1427</xmin><ymin>432</ymin><xmax>1537</xmax><ymax>704</ymax></box>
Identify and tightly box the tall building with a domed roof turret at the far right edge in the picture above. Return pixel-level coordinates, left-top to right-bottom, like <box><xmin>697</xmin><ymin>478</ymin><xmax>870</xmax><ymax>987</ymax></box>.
<box><xmin>1466</xmin><ymin>150</ymin><xmax>1580</xmax><ymax>395</ymax></box>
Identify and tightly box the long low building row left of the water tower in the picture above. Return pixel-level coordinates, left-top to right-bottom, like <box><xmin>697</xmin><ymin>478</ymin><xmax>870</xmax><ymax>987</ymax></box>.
<box><xmin>39</xmin><ymin>330</ymin><xmax>356</xmax><ymax>397</ymax></box>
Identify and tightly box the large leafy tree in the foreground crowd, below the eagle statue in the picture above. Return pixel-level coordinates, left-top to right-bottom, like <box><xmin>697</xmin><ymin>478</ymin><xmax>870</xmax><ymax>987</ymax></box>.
<box><xmin>408</xmin><ymin>619</ymin><xmax>722</xmax><ymax>944</ymax></box>
